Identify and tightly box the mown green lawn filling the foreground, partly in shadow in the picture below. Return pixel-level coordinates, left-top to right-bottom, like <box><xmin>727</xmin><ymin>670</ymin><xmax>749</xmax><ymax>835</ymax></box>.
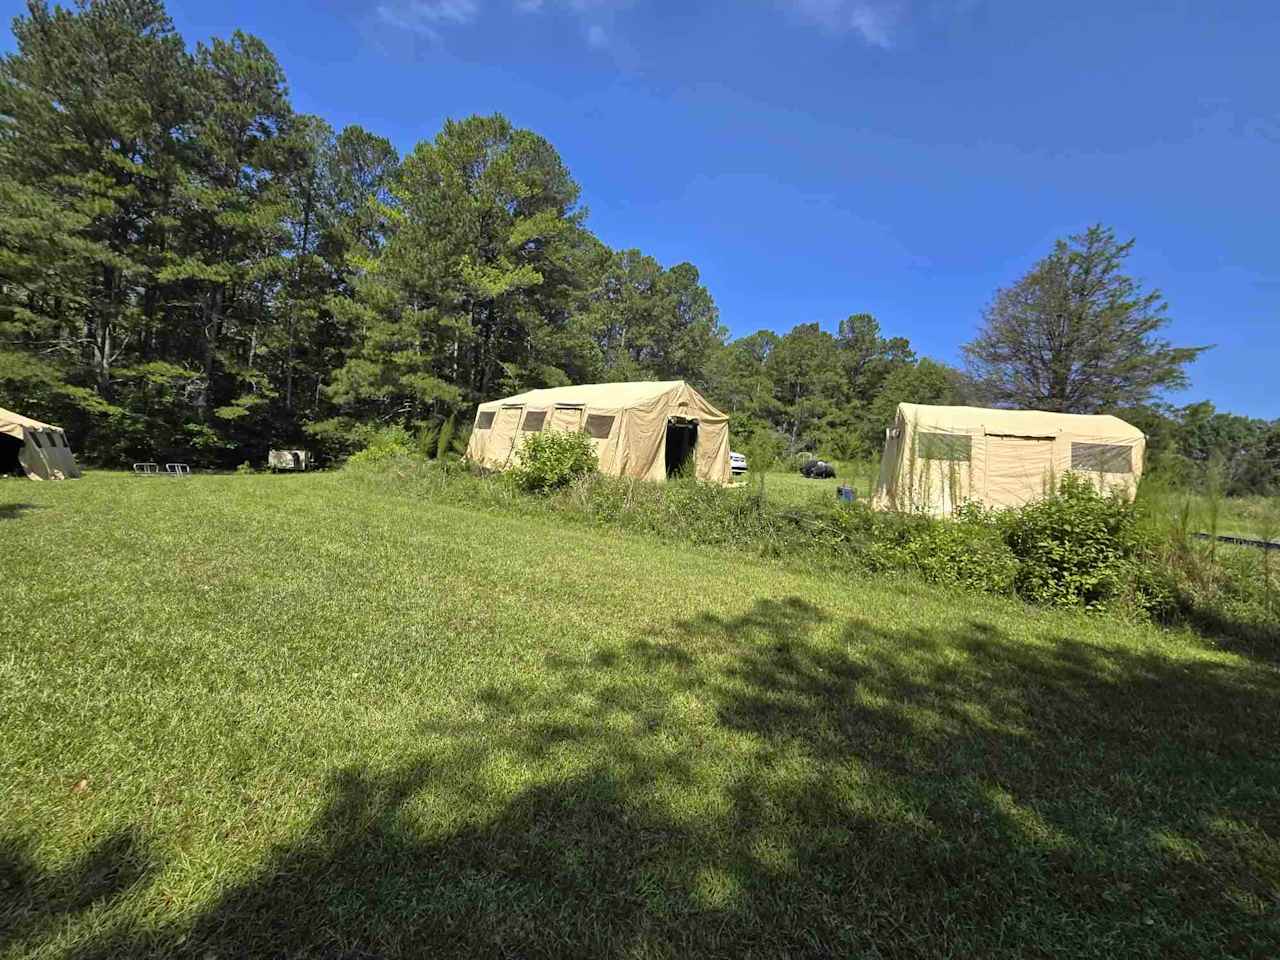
<box><xmin>0</xmin><ymin>474</ymin><xmax>1280</xmax><ymax>960</ymax></box>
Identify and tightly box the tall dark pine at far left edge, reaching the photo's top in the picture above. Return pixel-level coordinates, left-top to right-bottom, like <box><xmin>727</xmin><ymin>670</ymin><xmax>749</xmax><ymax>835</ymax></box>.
<box><xmin>0</xmin><ymin>0</ymin><xmax>192</xmax><ymax>422</ymax></box>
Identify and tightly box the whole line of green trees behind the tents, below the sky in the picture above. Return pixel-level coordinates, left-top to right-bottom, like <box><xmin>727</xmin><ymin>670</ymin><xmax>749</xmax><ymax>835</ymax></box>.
<box><xmin>0</xmin><ymin>0</ymin><xmax>1280</xmax><ymax>490</ymax></box>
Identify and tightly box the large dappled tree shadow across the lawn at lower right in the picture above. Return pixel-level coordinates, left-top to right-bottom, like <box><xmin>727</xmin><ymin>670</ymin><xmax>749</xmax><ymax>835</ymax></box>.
<box><xmin>22</xmin><ymin>598</ymin><xmax>1280</xmax><ymax>957</ymax></box>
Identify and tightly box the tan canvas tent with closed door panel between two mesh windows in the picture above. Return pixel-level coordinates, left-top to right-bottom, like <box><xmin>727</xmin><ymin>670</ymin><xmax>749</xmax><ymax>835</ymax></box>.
<box><xmin>874</xmin><ymin>403</ymin><xmax>1147</xmax><ymax>515</ymax></box>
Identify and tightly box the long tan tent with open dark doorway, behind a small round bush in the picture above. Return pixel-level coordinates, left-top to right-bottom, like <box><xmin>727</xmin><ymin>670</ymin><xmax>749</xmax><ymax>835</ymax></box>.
<box><xmin>467</xmin><ymin>380</ymin><xmax>730</xmax><ymax>483</ymax></box>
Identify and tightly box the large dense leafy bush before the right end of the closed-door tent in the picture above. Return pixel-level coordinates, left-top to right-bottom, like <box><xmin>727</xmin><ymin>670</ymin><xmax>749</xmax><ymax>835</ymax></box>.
<box><xmin>997</xmin><ymin>474</ymin><xmax>1171</xmax><ymax>611</ymax></box>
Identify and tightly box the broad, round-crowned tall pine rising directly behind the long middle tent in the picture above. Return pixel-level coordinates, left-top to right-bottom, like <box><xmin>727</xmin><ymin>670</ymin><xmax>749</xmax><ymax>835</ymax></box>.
<box><xmin>330</xmin><ymin>116</ymin><xmax>589</xmax><ymax>422</ymax></box>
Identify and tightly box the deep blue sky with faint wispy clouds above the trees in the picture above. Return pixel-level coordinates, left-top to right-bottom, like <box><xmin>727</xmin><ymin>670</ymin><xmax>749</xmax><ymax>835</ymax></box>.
<box><xmin>0</xmin><ymin>0</ymin><xmax>1280</xmax><ymax>419</ymax></box>
